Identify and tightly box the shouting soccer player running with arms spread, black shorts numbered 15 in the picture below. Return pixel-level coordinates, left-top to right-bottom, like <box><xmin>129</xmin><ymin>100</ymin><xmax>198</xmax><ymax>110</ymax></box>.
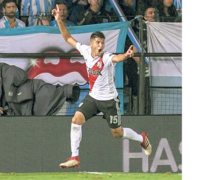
<box><xmin>52</xmin><ymin>5</ymin><xmax>152</xmax><ymax>168</ymax></box>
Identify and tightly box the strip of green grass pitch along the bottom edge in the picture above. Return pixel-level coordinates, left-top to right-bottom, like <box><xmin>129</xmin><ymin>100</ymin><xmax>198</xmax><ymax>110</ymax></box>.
<box><xmin>0</xmin><ymin>173</ymin><xmax>184</xmax><ymax>180</ymax></box>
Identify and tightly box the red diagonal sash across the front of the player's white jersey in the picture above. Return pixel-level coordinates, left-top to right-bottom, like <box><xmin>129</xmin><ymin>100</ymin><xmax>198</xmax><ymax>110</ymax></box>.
<box><xmin>88</xmin><ymin>57</ymin><xmax>104</xmax><ymax>91</ymax></box>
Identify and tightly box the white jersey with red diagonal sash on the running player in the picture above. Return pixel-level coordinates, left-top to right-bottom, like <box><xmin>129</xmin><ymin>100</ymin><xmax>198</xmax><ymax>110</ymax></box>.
<box><xmin>76</xmin><ymin>43</ymin><xmax>118</xmax><ymax>101</ymax></box>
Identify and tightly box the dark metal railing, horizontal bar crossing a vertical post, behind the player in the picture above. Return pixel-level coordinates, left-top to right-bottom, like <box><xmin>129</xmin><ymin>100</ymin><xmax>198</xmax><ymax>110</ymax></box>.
<box><xmin>0</xmin><ymin>17</ymin><xmax>184</xmax><ymax>115</ymax></box>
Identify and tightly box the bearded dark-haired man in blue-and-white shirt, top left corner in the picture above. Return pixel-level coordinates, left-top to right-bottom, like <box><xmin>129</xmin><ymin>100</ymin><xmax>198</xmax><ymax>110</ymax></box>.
<box><xmin>0</xmin><ymin>0</ymin><xmax>25</xmax><ymax>29</ymax></box>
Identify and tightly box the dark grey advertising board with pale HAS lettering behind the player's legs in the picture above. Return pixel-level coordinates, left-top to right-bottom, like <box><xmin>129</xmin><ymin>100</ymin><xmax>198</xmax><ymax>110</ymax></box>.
<box><xmin>0</xmin><ymin>115</ymin><xmax>184</xmax><ymax>173</ymax></box>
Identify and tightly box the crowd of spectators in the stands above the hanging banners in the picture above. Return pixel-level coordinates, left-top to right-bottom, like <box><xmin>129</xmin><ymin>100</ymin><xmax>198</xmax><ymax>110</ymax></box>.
<box><xmin>0</xmin><ymin>0</ymin><xmax>184</xmax><ymax>28</ymax></box>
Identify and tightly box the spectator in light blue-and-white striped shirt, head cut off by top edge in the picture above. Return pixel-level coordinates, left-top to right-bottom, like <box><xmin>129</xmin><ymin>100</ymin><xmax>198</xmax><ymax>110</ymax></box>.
<box><xmin>21</xmin><ymin>0</ymin><xmax>55</xmax><ymax>26</ymax></box>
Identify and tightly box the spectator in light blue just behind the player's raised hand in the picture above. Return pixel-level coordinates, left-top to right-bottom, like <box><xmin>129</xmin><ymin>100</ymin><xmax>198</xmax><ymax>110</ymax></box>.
<box><xmin>50</xmin><ymin>3</ymin><xmax>76</xmax><ymax>27</ymax></box>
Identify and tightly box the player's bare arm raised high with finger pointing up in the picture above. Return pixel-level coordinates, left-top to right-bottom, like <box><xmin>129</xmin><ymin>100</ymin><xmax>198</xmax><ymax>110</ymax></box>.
<box><xmin>52</xmin><ymin>5</ymin><xmax>77</xmax><ymax>49</ymax></box>
